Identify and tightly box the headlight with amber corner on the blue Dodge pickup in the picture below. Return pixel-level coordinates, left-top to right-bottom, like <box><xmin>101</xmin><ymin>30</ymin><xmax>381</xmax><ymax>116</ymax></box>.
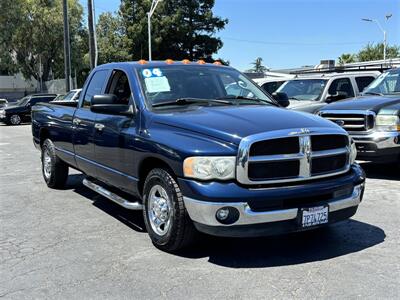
<box><xmin>183</xmin><ymin>156</ymin><xmax>236</xmax><ymax>180</ymax></box>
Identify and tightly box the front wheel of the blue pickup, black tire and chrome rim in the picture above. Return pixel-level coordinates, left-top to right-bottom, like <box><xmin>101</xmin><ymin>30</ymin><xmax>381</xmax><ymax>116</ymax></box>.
<box><xmin>143</xmin><ymin>169</ymin><xmax>196</xmax><ymax>252</ymax></box>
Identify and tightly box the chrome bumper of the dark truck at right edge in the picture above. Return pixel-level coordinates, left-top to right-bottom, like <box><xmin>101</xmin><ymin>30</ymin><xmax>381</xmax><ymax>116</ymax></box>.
<box><xmin>350</xmin><ymin>131</ymin><xmax>400</xmax><ymax>150</ymax></box>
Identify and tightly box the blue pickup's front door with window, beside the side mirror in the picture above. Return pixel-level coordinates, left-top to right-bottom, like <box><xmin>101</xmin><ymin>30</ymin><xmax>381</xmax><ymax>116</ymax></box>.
<box><xmin>94</xmin><ymin>69</ymin><xmax>137</xmax><ymax>192</ymax></box>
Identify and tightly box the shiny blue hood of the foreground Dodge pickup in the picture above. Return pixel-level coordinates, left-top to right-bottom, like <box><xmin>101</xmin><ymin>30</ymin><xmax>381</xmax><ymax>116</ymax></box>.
<box><xmin>153</xmin><ymin>106</ymin><xmax>340</xmax><ymax>144</ymax></box>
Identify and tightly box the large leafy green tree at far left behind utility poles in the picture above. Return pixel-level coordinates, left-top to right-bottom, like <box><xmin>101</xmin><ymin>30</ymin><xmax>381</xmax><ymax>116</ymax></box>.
<box><xmin>0</xmin><ymin>0</ymin><xmax>83</xmax><ymax>88</ymax></box>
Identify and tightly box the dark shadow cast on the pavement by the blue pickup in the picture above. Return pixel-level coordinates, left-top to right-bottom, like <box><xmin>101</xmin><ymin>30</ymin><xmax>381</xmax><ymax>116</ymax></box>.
<box><xmin>67</xmin><ymin>175</ymin><xmax>386</xmax><ymax>268</ymax></box>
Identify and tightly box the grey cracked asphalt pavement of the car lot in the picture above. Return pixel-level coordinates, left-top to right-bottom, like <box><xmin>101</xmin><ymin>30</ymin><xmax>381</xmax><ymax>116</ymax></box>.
<box><xmin>0</xmin><ymin>125</ymin><xmax>400</xmax><ymax>299</ymax></box>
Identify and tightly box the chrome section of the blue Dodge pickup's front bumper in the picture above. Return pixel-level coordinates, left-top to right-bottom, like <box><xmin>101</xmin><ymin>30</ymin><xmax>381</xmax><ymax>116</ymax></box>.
<box><xmin>183</xmin><ymin>184</ymin><xmax>364</xmax><ymax>226</ymax></box>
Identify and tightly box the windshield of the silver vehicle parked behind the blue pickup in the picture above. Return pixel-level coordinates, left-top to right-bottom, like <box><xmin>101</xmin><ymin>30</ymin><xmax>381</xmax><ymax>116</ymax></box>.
<box><xmin>276</xmin><ymin>79</ymin><xmax>327</xmax><ymax>101</ymax></box>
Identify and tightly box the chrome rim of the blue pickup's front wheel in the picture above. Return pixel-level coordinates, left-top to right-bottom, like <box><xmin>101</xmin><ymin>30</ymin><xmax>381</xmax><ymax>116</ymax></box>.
<box><xmin>147</xmin><ymin>185</ymin><xmax>173</xmax><ymax>236</ymax></box>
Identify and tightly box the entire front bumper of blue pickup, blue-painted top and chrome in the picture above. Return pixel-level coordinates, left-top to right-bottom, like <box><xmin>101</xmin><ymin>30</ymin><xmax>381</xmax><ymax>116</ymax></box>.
<box><xmin>181</xmin><ymin>165</ymin><xmax>365</xmax><ymax>237</ymax></box>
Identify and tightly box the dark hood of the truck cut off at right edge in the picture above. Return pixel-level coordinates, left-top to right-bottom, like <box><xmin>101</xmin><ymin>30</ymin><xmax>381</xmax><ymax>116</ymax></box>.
<box><xmin>323</xmin><ymin>95</ymin><xmax>400</xmax><ymax>113</ymax></box>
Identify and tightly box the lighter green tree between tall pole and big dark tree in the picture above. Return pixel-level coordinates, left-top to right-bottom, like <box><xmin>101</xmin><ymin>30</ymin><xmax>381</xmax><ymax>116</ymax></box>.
<box><xmin>96</xmin><ymin>12</ymin><xmax>129</xmax><ymax>64</ymax></box>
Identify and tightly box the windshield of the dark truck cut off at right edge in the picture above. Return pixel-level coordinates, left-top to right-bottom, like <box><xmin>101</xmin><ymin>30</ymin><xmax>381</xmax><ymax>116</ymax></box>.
<box><xmin>363</xmin><ymin>70</ymin><xmax>400</xmax><ymax>95</ymax></box>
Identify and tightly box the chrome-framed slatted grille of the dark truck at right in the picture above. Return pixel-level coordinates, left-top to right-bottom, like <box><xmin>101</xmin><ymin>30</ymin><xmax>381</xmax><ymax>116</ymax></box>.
<box><xmin>320</xmin><ymin>111</ymin><xmax>375</xmax><ymax>132</ymax></box>
